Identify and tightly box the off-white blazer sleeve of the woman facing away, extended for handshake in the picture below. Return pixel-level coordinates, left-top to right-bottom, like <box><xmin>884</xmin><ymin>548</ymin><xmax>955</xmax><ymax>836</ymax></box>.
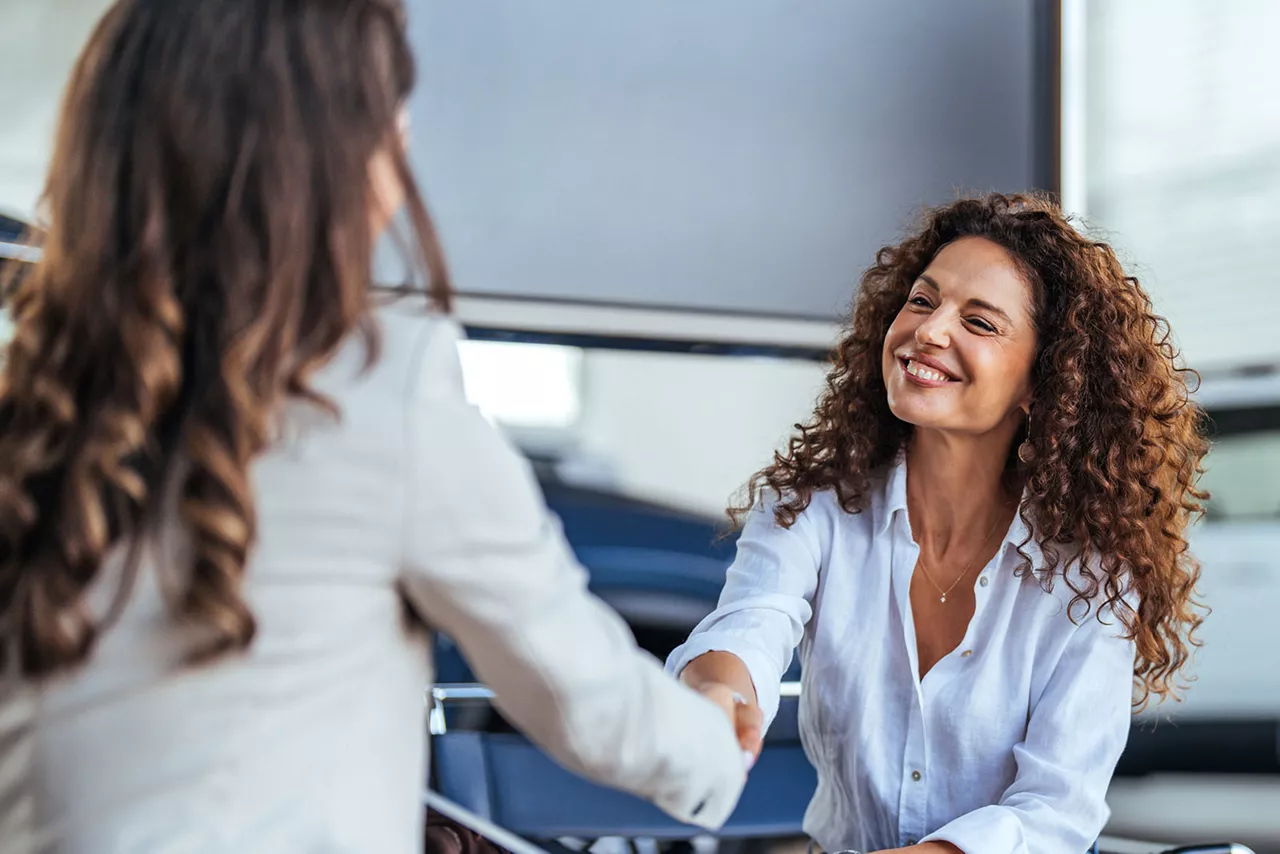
<box><xmin>401</xmin><ymin>320</ymin><xmax>745</xmax><ymax>828</ymax></box>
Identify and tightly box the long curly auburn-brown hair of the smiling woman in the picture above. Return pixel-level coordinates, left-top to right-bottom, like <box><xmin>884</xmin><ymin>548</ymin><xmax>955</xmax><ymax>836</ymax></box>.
<box><xmin>728</xmin><ymin>195</ymin><xmax>1208</xmax><ymax>708</ymax></box>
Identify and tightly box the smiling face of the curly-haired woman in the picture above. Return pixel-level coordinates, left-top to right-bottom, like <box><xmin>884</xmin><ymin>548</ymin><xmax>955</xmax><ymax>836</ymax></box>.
<box><xmin>883</xmin><ymin>237</ymin><xmax>1036</xmax><ymax>435</ymax></box>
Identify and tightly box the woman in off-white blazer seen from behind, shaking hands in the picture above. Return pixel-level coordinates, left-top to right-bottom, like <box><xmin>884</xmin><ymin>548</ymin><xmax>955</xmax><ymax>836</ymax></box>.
<box><xmin>0</xmin><ymin>0</ymin><xmax>744</xmax><ymax>854</ymax></box>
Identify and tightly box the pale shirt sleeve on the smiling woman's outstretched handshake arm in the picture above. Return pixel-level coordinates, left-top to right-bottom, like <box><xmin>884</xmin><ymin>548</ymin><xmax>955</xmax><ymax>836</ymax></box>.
<box><xmin>667</xmin><ymin>503</ymin><xmax>822</xmax><ymax>727</ymax></box>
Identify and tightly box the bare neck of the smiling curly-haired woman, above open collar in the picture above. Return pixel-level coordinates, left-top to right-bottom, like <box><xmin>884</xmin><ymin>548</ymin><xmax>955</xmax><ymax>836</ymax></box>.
<box><xmin>906</xmin><ymin>430</ymin><xmax>1018</xmax><ymax>556</ymax></box>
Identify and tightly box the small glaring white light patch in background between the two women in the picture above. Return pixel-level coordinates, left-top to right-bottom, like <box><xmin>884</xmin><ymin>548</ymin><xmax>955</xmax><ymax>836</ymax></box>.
<box><xmin>458</xmin><ymin>341</ymin><xmax>582</xmax><ymax>428</ymax></box>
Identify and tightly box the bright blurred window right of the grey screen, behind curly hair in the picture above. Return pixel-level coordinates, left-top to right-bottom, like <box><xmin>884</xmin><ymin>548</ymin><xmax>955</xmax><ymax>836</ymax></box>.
<box><xmin>1064</xmin><ymin>0</ymin><xmax>1280</xmax><ymax>370</ymax></box>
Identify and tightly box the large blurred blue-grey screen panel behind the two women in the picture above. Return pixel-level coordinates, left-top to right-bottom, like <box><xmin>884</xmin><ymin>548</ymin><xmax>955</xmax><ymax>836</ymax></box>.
<box><xmin>410</xmin><ymin>0</ymin><xmax>1057</xmax><ymax>320</ymax></box>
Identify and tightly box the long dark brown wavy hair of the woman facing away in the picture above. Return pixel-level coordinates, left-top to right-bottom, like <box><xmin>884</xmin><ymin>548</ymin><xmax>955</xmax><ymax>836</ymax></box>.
<box><xmin>0</xmin><ymin>0</ymin><xmax>449</xmax><ymax>676</ymax></box>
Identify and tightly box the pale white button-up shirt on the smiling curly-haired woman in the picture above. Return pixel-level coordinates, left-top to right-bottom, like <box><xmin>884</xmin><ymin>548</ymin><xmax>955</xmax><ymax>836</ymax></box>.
<box><xmin>667</xmin><ymin>463</ymin><xmax>1134</xmax><ymax>854</ymax></box>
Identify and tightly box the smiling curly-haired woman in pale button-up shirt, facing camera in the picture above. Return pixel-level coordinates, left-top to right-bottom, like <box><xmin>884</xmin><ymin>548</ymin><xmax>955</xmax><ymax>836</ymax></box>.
<box><xmin>668</xmin><ymin>195</ymin><xmax>1206</xmax><ymax>854</ymax></box>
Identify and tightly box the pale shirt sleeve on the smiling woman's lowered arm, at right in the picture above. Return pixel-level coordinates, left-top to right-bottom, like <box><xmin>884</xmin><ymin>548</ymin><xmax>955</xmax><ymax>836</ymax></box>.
<box><xmin>922</xmin><ymin>601</ymin><xmax>1134</xmax><ymax>854</ymax></box>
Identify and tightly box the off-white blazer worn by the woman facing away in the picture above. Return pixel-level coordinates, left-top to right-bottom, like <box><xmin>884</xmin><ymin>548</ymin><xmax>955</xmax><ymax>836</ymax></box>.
<box><xmin>0</xmin><ymin>300</ymin><xmax>744</xmax><ymax>854</ymax></box>
